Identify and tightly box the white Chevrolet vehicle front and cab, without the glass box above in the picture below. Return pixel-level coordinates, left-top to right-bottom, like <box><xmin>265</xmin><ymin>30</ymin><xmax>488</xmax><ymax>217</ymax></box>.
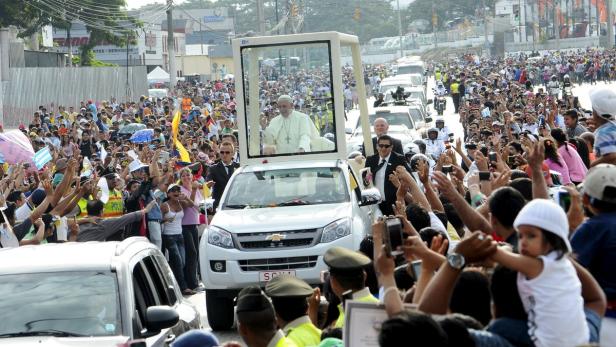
<box><xmin>199</xmin><ymin>160</ymin><xmax>380</xmax><ymax>330</ymax></box>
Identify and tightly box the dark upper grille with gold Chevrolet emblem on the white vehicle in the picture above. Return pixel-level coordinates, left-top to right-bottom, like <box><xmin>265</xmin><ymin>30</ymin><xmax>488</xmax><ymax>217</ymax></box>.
<box><xmin>235</xmin><ymin>229</ymin><xmax>319</xmax><ymax>251</ymax></box>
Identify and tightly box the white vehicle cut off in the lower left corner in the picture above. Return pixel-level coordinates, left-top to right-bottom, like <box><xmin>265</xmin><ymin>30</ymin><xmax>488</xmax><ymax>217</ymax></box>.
<box><xmin>0</xmin><ymin>237</ymin><xmax>201</xmax><ymax>347</ymax></box>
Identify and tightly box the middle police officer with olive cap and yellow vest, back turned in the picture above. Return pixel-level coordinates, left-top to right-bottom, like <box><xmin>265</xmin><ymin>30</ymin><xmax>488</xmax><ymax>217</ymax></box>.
<box><xmin>265</xmin><ymin>275</ymin><xmax>321</xmax><ymax>347</ymax></box>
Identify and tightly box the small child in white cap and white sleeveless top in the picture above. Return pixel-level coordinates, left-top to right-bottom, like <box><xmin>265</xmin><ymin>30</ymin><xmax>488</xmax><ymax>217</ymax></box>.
<box><xmin>492</xmin><ymin>199</ymin><xmax>590</xmax><ymax>347</ymax></box>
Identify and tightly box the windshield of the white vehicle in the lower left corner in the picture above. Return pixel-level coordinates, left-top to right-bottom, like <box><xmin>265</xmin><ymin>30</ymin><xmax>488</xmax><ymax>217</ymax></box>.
<box><xmin>0</xmin><ymin>271</ymin><xmax>122</xmax><ymax>338</ymax></box>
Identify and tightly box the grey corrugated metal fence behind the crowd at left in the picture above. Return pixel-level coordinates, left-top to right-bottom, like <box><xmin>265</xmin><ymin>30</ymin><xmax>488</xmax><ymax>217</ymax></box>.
<box><xmin>0</xmin><ymin>66</ymin><xmax>148</xmax><ymax>128</ymax></box>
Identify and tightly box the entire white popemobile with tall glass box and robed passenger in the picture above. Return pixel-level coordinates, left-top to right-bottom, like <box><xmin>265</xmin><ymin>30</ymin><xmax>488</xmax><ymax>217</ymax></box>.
<box><xmin>199</xmin><ymin>32</ymin><xmax>381</xmax><ymax>330</ymax></box>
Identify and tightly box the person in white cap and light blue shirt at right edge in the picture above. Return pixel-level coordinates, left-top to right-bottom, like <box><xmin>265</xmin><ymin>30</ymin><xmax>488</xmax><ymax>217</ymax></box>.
<box><xmin>590</xmin><ymin>88</ymin><xmax>616</xmax><ymax>166</ymax></box>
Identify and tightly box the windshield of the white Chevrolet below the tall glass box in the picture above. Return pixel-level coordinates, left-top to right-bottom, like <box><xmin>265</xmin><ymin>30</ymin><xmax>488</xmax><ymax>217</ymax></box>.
<box><xmin>223</xmin><ymin>167</ymin><xmax>349</xmax><ymax>209</ymax></box>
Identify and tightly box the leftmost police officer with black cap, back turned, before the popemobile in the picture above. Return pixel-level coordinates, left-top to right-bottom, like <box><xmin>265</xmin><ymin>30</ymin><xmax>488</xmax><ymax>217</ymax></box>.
<box><xmin>236</xmin><ymin>286</ymin><xmax>297</xmax><ymax>347</ymax></box>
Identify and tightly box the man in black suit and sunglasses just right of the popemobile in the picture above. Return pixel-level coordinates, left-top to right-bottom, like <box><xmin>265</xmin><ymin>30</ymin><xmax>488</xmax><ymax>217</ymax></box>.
<box><xmin>366</xmin><ymin>135</ymin><xmax>411</xmax><ymax>216</ymax></box>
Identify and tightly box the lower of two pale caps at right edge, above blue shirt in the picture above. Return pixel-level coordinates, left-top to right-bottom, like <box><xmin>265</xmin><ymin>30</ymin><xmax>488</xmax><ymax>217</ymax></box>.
<box><xmin>582</xmin><ymin>164</ymin><xmax>616</xmax><ymax>203</ymax></box>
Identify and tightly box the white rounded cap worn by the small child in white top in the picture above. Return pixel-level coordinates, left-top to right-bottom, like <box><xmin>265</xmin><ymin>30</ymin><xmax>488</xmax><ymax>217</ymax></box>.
<box><xmin>513</xmin><ymin>199</ymin><xmax>571</xmax><ymax>252</ymax></box>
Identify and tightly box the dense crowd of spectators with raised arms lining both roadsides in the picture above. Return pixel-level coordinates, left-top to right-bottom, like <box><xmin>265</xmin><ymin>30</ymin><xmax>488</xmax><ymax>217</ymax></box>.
<box><xmin>0</xmin><ymin>50</ymin><xmax>616</xmax><ymax>347</ymax></box>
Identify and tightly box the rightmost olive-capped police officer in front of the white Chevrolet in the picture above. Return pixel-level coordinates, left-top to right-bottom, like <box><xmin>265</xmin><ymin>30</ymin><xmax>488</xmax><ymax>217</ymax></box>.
<box><xmin>323</xmin><ymin>247</ymin><xmax>379</xmax><ymax>328</ymax></box>
